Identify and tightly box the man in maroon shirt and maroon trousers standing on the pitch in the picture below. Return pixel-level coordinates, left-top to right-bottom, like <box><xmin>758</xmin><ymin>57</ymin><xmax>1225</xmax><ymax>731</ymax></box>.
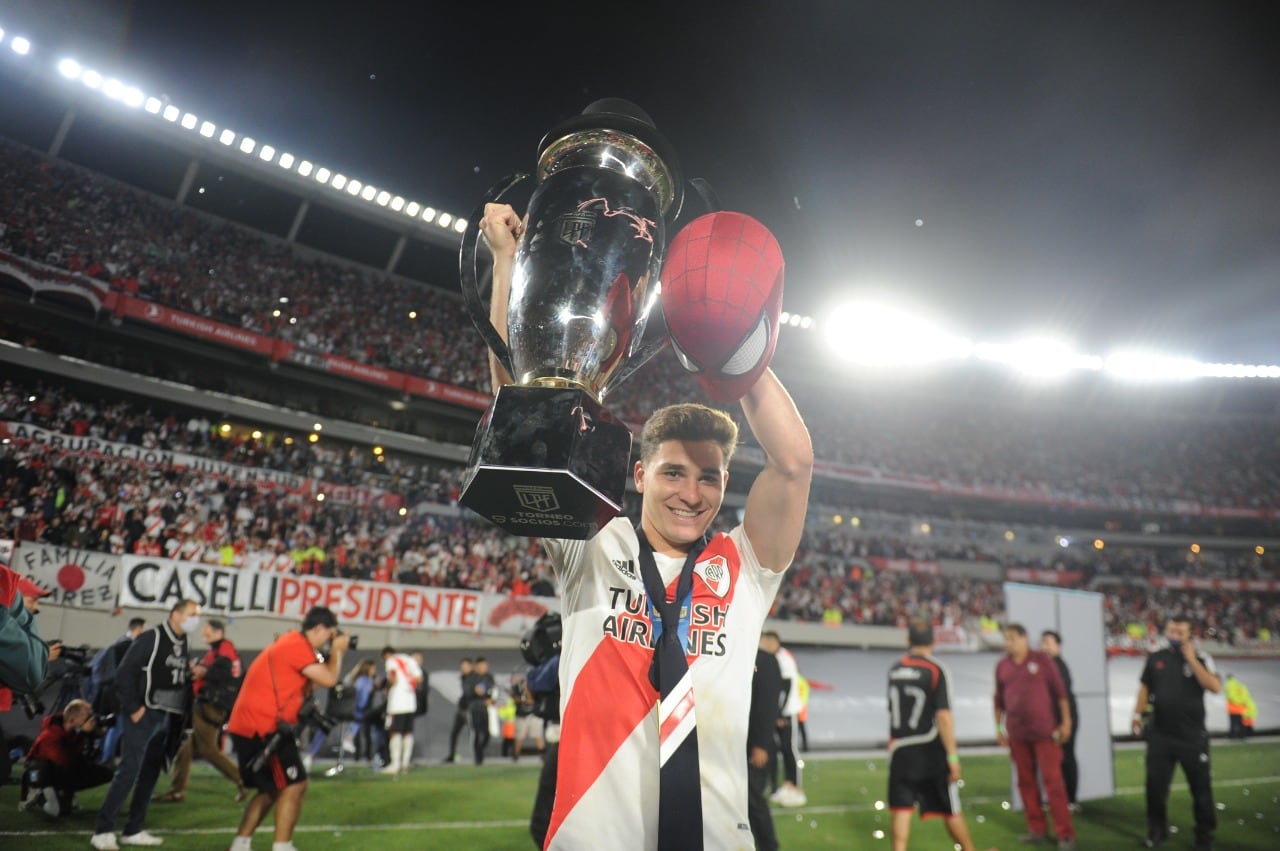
<box><xmin>996</xmin><ymin>623</ymin><xmax>1075</xmax><ymax>851</ymax></box>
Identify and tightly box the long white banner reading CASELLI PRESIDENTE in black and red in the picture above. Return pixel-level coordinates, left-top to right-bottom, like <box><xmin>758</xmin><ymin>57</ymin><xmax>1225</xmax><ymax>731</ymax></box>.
<box><xmin>120</xmin><ymin>555</ymin><xmax>559</xmax><ymax>635</ymax></box>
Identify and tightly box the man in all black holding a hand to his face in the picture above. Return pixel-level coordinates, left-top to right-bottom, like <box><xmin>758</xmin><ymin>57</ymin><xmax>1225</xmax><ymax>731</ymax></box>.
<box><xmin>1133</xmin><ymin>616</ymin><xmax>1222</xmax><ymax>851</ymax></box>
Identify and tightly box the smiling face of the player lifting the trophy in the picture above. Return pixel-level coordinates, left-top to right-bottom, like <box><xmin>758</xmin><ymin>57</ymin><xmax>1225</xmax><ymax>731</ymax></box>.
<box><xmin>635</xmin><ymin>440</ymin><xmax>728</xmax><ymax>555</ymax></box>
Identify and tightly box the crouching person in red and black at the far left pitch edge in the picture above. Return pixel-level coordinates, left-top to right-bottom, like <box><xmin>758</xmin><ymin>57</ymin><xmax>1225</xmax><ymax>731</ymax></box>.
<box><xmin>18</xmin><ymin>700</ymin><xmax>111</xmax><ymax>818</ymax></box>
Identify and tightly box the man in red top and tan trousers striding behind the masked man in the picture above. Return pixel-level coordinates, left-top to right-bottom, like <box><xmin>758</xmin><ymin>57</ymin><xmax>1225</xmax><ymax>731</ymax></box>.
<box><xmin>156</xmin><ymin>618</ymin><xmax>248</xmax><ymax>804</ymax></box>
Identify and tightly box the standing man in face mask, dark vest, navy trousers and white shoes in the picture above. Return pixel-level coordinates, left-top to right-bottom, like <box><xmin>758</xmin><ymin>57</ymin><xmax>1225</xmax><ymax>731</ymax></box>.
<box><xmin>90</xmin><ymin>600</ymin><xmax>200</xmax><ymax>851</ymax></box>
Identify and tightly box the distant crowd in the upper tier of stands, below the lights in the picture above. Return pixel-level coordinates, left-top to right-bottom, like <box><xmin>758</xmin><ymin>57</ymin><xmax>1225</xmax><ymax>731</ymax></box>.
<box><xmin>0</xmin><ymin>141</ymin><xmax>1280</xmax><ymax>512</ymax></box>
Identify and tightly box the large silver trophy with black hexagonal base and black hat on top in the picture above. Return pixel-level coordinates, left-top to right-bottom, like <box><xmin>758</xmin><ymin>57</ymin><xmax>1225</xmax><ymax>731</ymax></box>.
<box><xmin>460</xmin><ymin>99</ymin><xmax>684</xmax><ymax>539</ymax></box>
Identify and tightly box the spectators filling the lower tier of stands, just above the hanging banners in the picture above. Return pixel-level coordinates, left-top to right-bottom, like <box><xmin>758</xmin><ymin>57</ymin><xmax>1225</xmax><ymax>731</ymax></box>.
<box><xmin>0</xmin><ymin>380</ymin><xmax>1280</xmax><ymax>640</ymax></box>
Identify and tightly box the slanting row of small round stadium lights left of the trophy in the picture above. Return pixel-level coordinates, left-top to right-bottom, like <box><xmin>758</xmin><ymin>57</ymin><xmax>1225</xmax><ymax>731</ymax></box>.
<box><xmin>0</xmin><ymin>27</ymin><xmax>467</xmax><ymax>234</ymax></box>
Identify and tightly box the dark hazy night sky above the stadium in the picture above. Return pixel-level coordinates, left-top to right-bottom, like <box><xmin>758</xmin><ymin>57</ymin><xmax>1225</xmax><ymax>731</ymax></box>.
<box><xmin>0</xmin><ymin>0</ymin><xmax>1280</xmax><ymax>363</ymax></box>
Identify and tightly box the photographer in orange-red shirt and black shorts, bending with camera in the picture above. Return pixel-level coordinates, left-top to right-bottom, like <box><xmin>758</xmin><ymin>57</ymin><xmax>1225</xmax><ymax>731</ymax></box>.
<box><xmin>227</xmin><ymin>605</ymin><xmax>351</xmax><ymax>851</ymax></box>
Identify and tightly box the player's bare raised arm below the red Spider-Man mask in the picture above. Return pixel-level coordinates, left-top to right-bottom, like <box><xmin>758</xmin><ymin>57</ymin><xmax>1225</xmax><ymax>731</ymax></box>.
<box><xmin>742</xmin><ymin>370</ymin><xmax>813</xmax><ymax>572</ymax></box>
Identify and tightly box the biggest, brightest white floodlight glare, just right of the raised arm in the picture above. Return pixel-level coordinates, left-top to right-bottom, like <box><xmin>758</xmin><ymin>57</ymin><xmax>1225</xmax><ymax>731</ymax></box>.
<box><xmin>819</xmin><ymin>301</ymin><xmax>973</xmax><ymax>366</ymax></box>
